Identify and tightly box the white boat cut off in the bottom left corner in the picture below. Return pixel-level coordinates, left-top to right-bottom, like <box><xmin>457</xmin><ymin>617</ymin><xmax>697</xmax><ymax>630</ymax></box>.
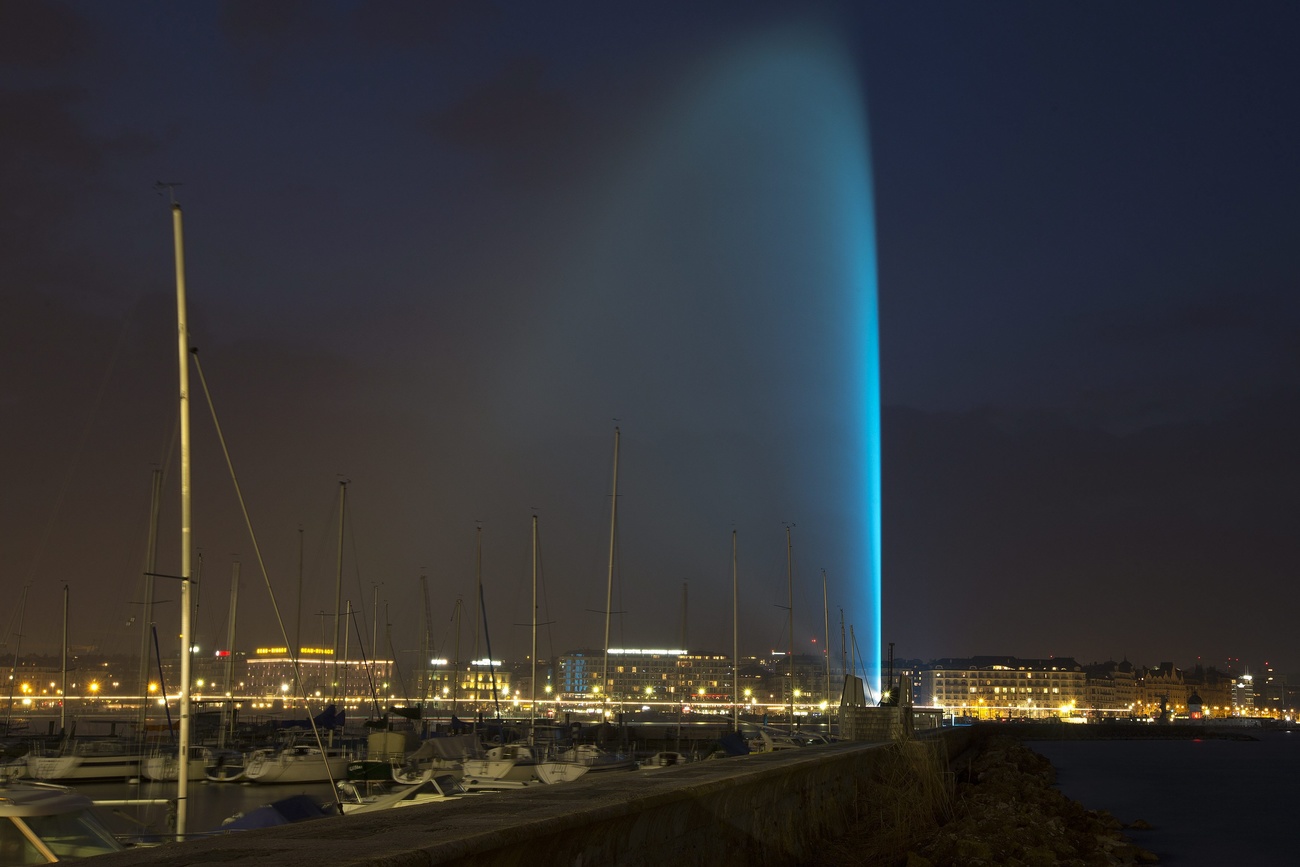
<box><xmin>0</xmin><ymin>777</ymin><xmax>124</xmax><ymax>867</ymax></box>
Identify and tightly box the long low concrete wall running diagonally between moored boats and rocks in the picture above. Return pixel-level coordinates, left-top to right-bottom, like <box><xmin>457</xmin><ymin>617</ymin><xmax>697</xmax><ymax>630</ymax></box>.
<box><xmin>86</xmin><ymin>733</ymin><xmax>965</xmax><ymax>867</ymax></box>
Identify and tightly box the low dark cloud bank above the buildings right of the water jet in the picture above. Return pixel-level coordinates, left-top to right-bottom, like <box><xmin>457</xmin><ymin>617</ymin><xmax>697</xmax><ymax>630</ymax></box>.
<box><xmin>884</xmin><ymin>398</ymin><xmax>1300</xmax><ymax>662</ymax></box>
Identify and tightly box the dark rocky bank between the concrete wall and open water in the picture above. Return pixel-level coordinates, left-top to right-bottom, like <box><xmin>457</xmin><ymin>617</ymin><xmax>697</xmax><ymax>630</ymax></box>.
<box><xmin>815</xmin><ymin>736</ymin><xmax>1160</xmax><ymax>867</ymax></box>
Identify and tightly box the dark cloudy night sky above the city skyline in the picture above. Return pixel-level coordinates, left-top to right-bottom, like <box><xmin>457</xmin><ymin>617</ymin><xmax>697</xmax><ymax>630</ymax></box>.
<box><xmin>0</xmin><ymin>0</ymin><xmax>1300</xmax><ymax>675</ymax></box>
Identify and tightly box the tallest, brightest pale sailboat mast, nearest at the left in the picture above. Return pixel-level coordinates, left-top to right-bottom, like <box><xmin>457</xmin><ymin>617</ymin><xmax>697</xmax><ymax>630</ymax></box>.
<box><xmin>172</xmin><ymin>201</ymin><xmax>194</xmax><ymax>840</ymax></box>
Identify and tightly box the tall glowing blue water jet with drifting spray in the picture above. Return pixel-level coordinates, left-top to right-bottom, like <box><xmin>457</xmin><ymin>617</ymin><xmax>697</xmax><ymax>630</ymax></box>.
<box><xmin>512</xmin><ymin>29</ymin><xmax>881</xmax><ymax>690</ymax></box>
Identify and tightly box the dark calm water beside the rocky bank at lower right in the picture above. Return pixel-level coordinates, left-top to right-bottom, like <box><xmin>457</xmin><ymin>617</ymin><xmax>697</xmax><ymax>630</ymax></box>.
<box><xmin>1028</xmin><ymin>732</ymin><xmax>1300</xmax><ymax>867</ymax></box>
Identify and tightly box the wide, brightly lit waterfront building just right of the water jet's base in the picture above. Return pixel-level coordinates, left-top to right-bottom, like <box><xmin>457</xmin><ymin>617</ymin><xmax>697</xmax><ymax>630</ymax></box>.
<box><xmin>919</xmin><ymin>656</ymin><xmax>1087</xmax><ymax>719</ymax></box>
